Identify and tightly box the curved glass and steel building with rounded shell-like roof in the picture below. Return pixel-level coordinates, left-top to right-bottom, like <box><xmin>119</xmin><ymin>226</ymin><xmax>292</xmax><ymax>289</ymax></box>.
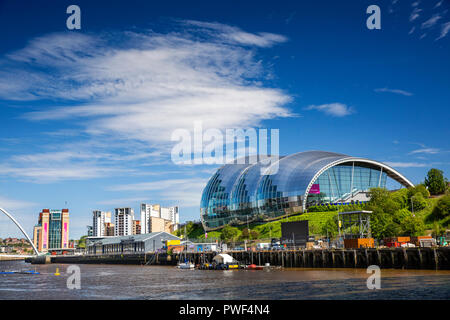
<box><xmin>200</xmin><ymin>151</ymin><xmax>413</xmax><ymax>230</ymax></box>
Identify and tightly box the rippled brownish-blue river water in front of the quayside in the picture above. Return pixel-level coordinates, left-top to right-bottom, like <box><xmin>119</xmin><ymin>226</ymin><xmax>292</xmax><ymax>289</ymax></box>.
<box><xmin>0</xmin><ymin>261</ymin><xmax>450</xmax><ymax>300</ymax></box>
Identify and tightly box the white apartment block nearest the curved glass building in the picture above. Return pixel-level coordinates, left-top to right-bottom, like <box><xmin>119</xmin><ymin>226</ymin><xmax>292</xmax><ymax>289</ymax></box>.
<box><xmin>141</xmin><ymin>203</ymin><xmax>180</xmax><ymax>234</ymax></box>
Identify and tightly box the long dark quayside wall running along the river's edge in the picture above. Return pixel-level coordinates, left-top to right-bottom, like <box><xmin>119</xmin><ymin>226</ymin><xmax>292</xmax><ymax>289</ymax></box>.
<box><xmin>26</xmin><ymin>247</ymin><xmax>450</xmax><ymax>270</ymax></box>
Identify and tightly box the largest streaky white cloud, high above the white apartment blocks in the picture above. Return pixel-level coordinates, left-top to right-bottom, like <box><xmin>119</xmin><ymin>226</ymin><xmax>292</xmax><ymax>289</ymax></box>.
<box><xmin>0</xmin><ymin>21</ymin><xmax>292</xmax><ymax>152</ymax></box>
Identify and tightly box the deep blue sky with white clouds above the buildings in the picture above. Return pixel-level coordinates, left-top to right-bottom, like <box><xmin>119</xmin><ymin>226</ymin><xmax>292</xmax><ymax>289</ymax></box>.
<box><xmin>0</xmin><ymin>0</ymin><xmax>450</xmax><ymax>238</ymax></box>
